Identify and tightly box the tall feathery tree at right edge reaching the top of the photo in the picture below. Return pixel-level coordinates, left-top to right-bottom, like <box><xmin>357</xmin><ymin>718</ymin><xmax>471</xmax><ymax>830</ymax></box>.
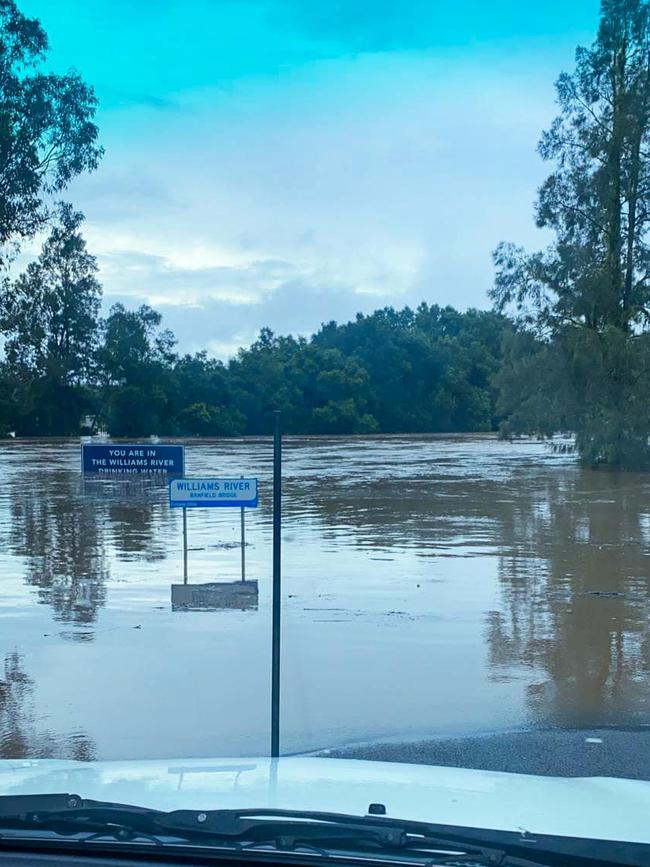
<box><xmin>492</xmin><ymin>0</ymin><xmax>650</xmax><ymax>467</ymax></box>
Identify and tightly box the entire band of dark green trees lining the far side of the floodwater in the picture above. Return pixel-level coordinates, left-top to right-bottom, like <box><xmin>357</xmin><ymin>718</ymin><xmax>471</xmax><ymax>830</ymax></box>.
<box><xmin>6</xmin><ymin>0</ymin><xmax>650</xmax><ymax>468</ymax></box>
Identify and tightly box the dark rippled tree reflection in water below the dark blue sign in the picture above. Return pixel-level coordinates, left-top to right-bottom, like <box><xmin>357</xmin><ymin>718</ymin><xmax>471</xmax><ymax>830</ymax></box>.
<box><xmin>8</xmin><ymin>469</ymin><xmax>173</xmax><ymax>628</ymax></box>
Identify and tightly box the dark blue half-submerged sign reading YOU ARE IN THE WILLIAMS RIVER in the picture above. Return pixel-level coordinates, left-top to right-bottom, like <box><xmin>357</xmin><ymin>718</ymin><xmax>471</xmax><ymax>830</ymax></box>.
<box><xmin>81</xmin><ymin>443</ymin><xmax>185</xmax><ymax>476</ymax></box>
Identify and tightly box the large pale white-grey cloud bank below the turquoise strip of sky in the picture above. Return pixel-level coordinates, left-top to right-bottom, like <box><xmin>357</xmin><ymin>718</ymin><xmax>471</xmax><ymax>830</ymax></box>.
<box><xmin>62</xmin><ymin>44</ymin><xmax>553</xmax><ymax>354</ymax></box>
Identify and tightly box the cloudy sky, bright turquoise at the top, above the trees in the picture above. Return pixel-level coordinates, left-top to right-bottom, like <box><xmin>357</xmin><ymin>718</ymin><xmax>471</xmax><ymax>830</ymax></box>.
<box><xmin>19</xmin><ymin>0</ymin><xmax>599</xmax><ymax>359</ymax></box>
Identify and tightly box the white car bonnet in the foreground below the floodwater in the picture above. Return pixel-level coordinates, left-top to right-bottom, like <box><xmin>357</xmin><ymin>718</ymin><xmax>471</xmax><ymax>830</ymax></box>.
<box><xmin>0</xmin><ymin>758</ymin><xmax>650</xmax><ymax>843</ymax></box>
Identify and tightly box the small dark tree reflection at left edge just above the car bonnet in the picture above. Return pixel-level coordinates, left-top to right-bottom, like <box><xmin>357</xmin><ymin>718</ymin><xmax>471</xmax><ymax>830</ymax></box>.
<box><xmin>0</xmin><ymin>652</ymin><xmax>95</xmax><ymax>761</ymax></box>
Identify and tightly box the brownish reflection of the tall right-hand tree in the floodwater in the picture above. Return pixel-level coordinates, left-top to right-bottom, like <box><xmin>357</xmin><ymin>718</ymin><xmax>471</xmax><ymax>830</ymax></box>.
<box><xmin>487</xmin><ymin>469</ymin><xmax>650</xmax><ymax>725</ymax></box>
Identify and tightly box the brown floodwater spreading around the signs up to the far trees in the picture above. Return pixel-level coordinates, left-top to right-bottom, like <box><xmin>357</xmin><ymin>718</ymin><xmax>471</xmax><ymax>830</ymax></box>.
<box><xmin>0</xmin><ymin>436</ymin><xmax>650</xmax><ymax>759</ymax></box>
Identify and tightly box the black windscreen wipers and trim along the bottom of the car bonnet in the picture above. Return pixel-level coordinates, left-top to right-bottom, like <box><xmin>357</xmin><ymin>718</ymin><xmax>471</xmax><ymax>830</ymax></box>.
<box><xmin>0</xmin><ymin>794</ymin><xmax>650</xmax><ymax>867</ymax></box>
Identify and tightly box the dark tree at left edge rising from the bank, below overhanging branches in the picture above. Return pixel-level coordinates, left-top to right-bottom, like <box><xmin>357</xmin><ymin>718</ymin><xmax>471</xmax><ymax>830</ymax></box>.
<box><xmin>0</xmin><ymin>205</ymin><xmax>101</xmax><ymax>434</ymax></box>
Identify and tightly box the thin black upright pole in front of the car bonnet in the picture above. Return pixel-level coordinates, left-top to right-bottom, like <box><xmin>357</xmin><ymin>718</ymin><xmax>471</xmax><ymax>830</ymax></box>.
<box><xmin>271</xmin><ymin>410</ymin><xmax>282</xmax><ymax>759</ymax></box>
